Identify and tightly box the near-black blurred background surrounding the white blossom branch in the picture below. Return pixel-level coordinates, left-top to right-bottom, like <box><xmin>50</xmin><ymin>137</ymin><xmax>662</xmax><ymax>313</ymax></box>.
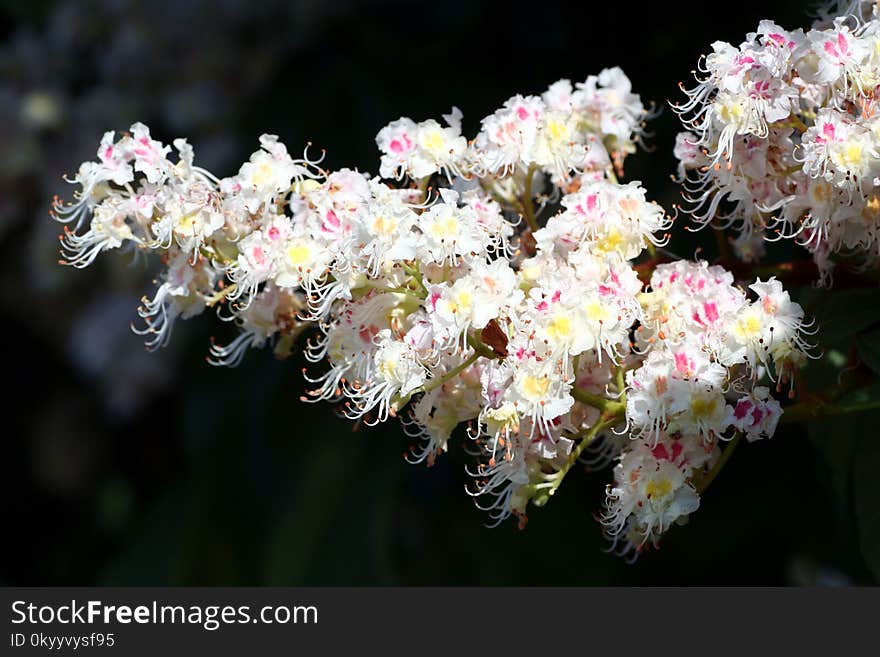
<box><xmin>0</xmin><ymin>0</ymin><xmax>876</xmax><ymax>585</ymax></box>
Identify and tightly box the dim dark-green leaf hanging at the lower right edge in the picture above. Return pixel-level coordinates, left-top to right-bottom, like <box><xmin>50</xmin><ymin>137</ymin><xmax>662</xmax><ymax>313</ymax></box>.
<box><xmin>853</xmin><ymin>430</ymin><xmax>880</xmax><ymax>579</ymax></box>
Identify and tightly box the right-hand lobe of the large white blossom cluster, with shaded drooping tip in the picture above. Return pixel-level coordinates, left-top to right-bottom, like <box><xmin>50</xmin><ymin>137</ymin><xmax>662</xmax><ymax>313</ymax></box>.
<box><xmin>602</xmin><ymin>261</ymin><xmax>809</xmax><ymax>552</ymax></box>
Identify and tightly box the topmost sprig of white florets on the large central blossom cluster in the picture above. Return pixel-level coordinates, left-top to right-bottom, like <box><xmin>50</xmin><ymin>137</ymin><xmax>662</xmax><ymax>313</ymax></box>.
<box><xmin>376</xmin><ymin>68</ymin><xmax>649</xmax><ymax>180</ymax></box>
